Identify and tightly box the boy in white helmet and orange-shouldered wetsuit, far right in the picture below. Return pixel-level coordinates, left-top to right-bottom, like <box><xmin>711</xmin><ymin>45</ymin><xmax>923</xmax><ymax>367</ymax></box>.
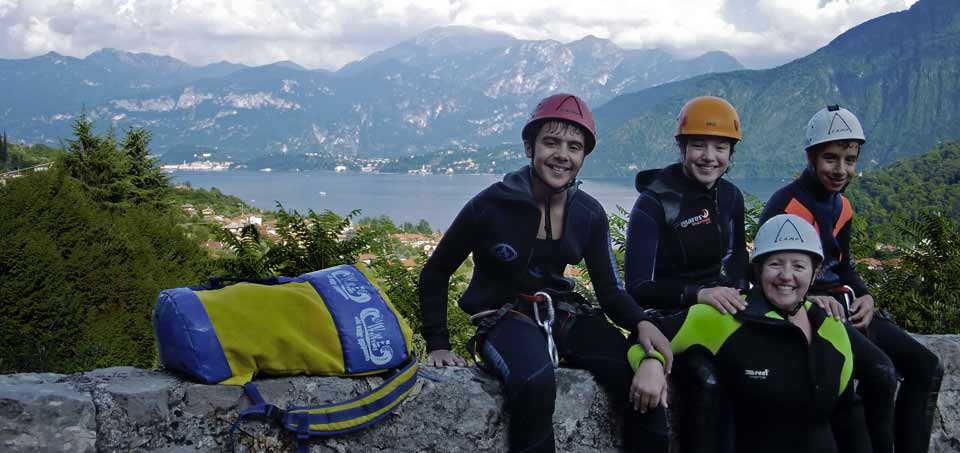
<box><xmin>760</xmin><ymin>105</ymin><xmax>943</xmax><ymax>453</ymax></box>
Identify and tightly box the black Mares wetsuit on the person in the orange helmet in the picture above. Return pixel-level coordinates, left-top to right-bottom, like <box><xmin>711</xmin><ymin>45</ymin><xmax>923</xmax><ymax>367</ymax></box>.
<box><xmin>624</xmin><ymin>164</ymin><xmax>747</xmax><ymax>453</ymax></box>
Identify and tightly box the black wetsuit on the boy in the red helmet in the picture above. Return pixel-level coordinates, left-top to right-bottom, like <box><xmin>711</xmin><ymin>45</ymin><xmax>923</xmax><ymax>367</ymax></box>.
<box><xmin>420</xmin><ymin>167</ymin><xmax>667</xmax><ymax>452</ymax></box>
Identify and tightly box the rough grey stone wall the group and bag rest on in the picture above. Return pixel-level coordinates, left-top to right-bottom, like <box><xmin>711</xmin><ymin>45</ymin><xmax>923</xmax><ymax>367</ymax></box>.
<box><xmin>0</xmin><ymin>335</ymin><xmax>960</xmax><ymax>452</ymax></box>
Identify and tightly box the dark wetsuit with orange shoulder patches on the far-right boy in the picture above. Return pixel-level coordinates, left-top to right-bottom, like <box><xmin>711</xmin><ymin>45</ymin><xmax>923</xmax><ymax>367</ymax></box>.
<box><xmin>760</xmin><ymin>169</ymin><xmax>943</xmax><ymax>453</ymax></box>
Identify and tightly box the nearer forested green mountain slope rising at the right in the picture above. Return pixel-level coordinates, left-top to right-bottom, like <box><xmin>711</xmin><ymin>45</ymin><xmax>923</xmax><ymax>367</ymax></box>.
<box><xmin>585</xmin><ymin>0</ymin><xmax>960</xmax><ymax>177</ymax></box>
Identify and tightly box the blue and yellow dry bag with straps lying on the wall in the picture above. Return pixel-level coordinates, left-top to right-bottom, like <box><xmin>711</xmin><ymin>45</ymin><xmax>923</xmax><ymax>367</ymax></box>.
<box><xmin>153</xmin><ymin>266</ymin><xmax>417</xmax><ymax>441</ymax></box>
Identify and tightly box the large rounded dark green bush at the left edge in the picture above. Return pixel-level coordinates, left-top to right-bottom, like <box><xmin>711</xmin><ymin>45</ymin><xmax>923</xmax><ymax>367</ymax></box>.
<box><xmin>0</xmin><ymin>167</ymin><xmax>207</xmax><ymax>373</ymax></box>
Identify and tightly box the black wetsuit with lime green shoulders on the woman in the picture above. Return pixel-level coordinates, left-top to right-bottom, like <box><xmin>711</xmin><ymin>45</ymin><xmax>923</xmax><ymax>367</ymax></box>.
<box><xmin>632</xmin><ymin>288</ymin><xmax>871</xmax><ymax>453</ymax></box>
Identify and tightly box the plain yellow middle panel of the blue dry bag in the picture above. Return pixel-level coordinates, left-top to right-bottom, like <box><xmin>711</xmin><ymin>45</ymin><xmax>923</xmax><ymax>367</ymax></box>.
<box><xmin>197</xmin><ymin>282</ymin><xmax>345</xmax><ymax>385</ymax></box>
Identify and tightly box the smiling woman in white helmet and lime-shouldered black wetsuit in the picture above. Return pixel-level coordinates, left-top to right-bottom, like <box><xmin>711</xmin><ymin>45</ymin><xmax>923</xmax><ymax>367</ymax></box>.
<box><xmin>628</xmin><ymin>214</ymin><xmax>871</xmax><ymax>453</ymax></box>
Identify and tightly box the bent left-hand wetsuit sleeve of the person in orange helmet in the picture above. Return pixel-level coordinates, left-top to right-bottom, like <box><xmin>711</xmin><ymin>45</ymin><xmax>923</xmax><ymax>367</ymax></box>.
<box><xmin>624</xmin><ymin>192</ymin><xmax>700</xmax><ymax>308</ymax></box>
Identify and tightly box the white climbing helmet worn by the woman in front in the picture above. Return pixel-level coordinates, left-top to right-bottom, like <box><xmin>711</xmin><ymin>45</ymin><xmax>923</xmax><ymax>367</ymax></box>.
<box><xmin>750</xmin><ymin>214</ymin><xmax>823</xmax><ymax>263</ymax></box>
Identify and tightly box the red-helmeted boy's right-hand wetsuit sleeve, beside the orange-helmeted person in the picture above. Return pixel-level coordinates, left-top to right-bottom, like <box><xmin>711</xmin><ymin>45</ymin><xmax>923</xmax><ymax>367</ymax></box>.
<box><xmin>583</xmin><ymin>205</ymin><xmax>650</xmax><ymax>332</ymax></box>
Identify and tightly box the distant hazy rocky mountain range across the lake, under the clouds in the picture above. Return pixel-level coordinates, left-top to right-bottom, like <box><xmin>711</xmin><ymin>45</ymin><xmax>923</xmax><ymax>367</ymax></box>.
<box><xmin>0</xmin><ymin>27</ymin><xmax>742</xmax><ymax>162</ymax></box>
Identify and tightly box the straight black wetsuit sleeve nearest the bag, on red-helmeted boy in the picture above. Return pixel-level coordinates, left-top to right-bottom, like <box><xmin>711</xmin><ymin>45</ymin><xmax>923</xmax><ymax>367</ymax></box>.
<box><xmin>419</xmin><ymin>199</ymin><xmax>476</xmax><ymax>352</ymax></box>
